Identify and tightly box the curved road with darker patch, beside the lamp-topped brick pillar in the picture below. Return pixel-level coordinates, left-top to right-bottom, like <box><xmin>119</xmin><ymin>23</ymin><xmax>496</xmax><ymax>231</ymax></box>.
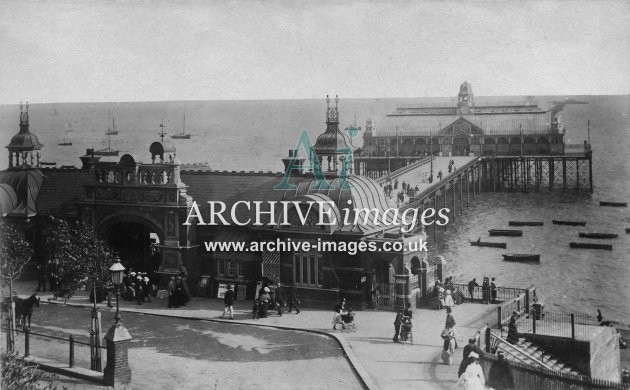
<box><xmin>8</xmin><ymin>303</ymin><xmax>361</xmax><ymax>389</ymax></box>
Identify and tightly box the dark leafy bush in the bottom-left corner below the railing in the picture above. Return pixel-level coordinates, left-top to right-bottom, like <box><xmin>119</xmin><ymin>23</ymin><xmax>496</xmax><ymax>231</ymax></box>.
<box><xmin>0</xmin><ymin>352</ymin><xmax>56</xmax><ymax>390</ymax></box>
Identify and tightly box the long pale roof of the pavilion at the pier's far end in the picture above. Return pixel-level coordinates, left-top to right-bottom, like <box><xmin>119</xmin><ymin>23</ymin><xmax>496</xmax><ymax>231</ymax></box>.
<box><xmin>372</xmin><ymin>112</ymin><xmax>551</xmax><ymax>136</ymax></box>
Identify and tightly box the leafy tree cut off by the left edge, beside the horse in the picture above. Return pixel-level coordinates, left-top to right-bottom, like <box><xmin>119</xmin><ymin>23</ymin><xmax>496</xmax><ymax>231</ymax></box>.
<box><xmin>0</xmin><ymin>219</ymin><xmax>33</xmax><ymax>289</ymax></box>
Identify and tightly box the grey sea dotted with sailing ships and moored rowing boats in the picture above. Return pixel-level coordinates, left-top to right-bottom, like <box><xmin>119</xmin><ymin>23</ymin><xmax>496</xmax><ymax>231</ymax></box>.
<box><xmin>0</xmin><ymin>95</ymin><xmax>630</xmax><ymax>326</ymax></box>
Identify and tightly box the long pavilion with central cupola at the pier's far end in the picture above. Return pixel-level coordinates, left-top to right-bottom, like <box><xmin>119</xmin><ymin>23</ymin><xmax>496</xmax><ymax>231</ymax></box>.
<box><xmin>362</xmin><ymin>82</ymin><xmax>565</xmax><ymax>157</ymax></box>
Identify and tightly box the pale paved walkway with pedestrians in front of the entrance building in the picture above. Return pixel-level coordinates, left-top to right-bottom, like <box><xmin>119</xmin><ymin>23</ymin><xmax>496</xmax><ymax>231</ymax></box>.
<box><xmin>4</xmin><ymin>283</ymin><xmax>496</xmax><ymax>390</ymax></box>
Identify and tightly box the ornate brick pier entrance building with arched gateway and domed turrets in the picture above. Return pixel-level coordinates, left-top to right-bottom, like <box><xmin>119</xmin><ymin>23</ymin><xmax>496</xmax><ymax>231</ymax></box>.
<box><xmin>0</xmin><ymin>101</ymin><xmax>436</xmax><ymax>308</ymax></box>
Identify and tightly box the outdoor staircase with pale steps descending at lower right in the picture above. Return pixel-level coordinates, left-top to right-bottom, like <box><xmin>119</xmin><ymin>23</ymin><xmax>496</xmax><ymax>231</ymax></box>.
<box><xmin>497</xmin><ymin>338</ymin><xmax>584</xmax><ymax>375</ymax></box>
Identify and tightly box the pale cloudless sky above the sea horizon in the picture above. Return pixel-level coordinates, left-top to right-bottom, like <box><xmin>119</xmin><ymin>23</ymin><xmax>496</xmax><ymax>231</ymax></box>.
<box><xmin>0</xmin><ymin>0</ymin><xmax>630</xmax><ymax>104</ymax></box>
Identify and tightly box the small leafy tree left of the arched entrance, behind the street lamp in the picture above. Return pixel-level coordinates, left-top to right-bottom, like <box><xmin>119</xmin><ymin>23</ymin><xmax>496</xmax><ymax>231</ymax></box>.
<box><xmin>46</xmin><ymin>218</ymin><xmax>114</xmax><ymax>301</ymax></box>
